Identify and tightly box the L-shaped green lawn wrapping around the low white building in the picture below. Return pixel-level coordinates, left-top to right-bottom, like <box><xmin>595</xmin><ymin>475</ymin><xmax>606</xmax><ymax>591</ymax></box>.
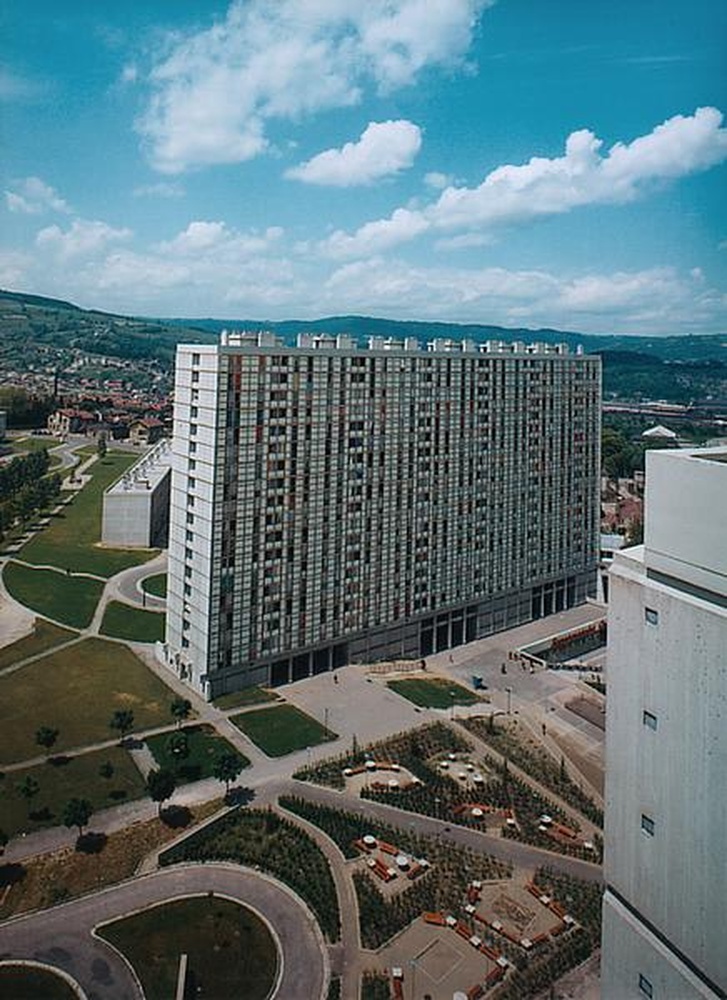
<box><xmin>22</xmin><ymin>451</ymin><xmax>156</xmax><ymax>576</ymax></box>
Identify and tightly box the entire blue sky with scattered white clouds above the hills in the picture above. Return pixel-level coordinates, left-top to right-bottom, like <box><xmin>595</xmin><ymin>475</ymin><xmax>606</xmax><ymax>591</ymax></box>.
<box><xmin>0</xmin><ymin>0</ymin><xmax>727</xmax><ymax>334</ymax></box>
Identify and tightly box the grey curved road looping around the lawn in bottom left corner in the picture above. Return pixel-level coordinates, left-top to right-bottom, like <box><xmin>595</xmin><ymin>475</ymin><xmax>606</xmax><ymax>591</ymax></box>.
<box><xmin>0</xmin><ymin>864</ymin><xmax>328</xmax><ymax>1000</ymax></box>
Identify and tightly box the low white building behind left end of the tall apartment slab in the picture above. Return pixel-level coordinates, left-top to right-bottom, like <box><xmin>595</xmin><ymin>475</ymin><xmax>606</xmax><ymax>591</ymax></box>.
<box><xmin>101</xmin><ymin>438</ymin><xmax>172</xmax><ymax>549</ymax></box>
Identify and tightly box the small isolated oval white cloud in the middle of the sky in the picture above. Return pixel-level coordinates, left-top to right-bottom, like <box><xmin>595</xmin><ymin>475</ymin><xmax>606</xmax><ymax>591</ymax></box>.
<box><xmin>285</xmin><ymin>120</ymin><xmax>422</xmax><ymax>187</ymax></box>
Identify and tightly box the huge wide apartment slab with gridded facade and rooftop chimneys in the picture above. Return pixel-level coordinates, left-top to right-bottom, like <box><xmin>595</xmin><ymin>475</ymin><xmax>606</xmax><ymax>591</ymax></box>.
<box><xmin>161</xmin><ymin>334</ymin><xmax>600</xmax><ymax>697</ymax></box>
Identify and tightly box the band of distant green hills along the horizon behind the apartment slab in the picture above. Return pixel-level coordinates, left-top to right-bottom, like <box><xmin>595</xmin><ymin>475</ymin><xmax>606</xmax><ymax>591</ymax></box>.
<box><xmin>0</xmin><ymin>290</ymin><xmax>727</xmax><ymax>403</ymax></box>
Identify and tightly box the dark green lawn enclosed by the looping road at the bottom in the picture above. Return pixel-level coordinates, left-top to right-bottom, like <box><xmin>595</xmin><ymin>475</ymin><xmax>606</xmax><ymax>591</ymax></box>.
<box><xmin>98</xmin><ymin>896</ymin><xmax>278</xmax><ymax>1000</ymax></box>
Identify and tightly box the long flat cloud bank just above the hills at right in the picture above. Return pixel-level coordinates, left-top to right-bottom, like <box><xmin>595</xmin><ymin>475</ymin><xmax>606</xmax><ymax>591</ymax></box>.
<box><xmin>322</xmin><ymin>257</ymin><xmax>727</xmax><ymax>335</ymax></box>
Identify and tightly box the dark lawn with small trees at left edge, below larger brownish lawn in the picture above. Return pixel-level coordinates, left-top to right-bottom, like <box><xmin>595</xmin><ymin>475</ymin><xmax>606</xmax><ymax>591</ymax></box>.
<box><xmin>0</xmin><ymin>746</ymin><xmax>146</xmax><ymax>837</ymax></box>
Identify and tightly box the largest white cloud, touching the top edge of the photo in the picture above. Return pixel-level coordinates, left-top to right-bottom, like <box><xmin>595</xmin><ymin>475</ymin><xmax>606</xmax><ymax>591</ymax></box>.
<box><xmin>137</xmin><ymin>0</ymin><xmax>493</xmax><ymax>174</ymax></box>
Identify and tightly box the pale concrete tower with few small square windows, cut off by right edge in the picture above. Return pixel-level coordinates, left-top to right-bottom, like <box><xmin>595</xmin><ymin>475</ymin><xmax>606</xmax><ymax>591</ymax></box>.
<box><xmin>601</xmin><ymin>448</ymin><xmax>727</xmax><ymax>1000</ymax></box>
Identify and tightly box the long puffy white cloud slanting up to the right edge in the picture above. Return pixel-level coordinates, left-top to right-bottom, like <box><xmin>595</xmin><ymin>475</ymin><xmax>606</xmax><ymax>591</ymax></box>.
<box><xmin>328</xmin><ymin>108</ymin><xmax>727</xmax><ymax>256</ymax></box>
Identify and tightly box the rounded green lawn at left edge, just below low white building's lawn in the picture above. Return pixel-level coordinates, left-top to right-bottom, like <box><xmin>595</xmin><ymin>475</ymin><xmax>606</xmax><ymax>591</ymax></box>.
<box><xmin>3</xmin><ymin>562</ymin><xmax>104</xmax><ymax>628</ymax></box>
